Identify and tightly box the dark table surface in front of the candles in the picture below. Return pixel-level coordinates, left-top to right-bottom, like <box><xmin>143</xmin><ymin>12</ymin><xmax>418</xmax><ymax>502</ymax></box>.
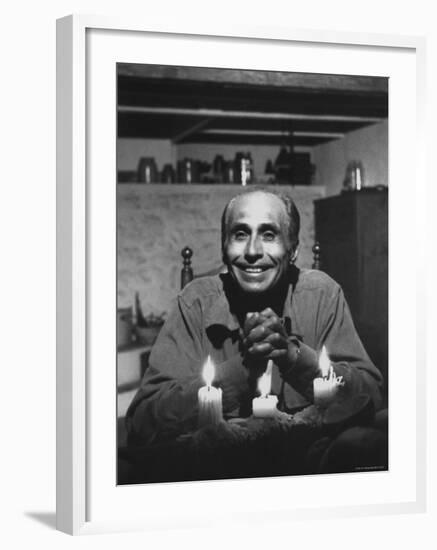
<box><xmin>118</xmin><ymin>406</ymin><xmax>388</xmax><ymax>485</ymax></box>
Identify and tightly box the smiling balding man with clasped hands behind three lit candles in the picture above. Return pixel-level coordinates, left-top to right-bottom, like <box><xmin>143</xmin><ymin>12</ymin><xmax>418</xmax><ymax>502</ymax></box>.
<box><xmin>126</xmin><ymin>188</ymin><xmax>382</xmax><ymax>444</ymax></box>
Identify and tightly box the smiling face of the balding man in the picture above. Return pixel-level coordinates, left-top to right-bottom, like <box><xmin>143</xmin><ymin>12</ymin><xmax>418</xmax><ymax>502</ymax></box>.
<box><xmin>223</xmin><ymin>192</ymin><xmax>291</xmax><ymax>294</ymax></box>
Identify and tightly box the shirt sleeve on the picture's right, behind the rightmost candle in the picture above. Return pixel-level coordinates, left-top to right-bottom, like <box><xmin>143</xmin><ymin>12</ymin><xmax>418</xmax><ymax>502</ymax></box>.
<box><xmin>282</xmin><ymin>284</ymin><xmax>383</xmax><ymax>409</ymax></box>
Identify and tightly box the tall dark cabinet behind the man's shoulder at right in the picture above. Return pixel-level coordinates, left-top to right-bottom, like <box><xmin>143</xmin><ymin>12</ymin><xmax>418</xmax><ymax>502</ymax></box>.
<box><xmin>314</xmin><ymin>189</ymin><xmax>388</xmax><ymax>396</ymax></box>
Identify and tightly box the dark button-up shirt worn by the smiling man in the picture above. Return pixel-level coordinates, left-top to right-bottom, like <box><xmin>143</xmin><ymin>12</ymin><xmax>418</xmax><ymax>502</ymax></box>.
<box><xmin>126</xmin><ymin>268</ymin><xmax>382</xmax><ymax>444</ymax></box>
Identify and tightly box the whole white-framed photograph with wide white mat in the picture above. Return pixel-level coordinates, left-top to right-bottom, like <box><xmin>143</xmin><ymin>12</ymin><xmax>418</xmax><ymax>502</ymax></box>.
<box><xmin>57</xmin><ymin>16</ymin><xmax>426</xmax><ymax>534</ymax></box>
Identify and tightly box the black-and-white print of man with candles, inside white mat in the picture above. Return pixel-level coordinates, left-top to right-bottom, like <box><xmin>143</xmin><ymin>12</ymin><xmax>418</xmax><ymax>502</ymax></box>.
<box><xmin>114</xmin><ymin>63</ymin><xmax>390</xmax><ymax>485</ymax></box>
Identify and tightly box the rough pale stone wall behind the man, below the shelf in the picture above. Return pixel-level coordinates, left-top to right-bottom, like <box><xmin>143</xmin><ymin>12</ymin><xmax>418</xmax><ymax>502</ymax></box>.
<box><xmin>117</xmin><ymin>184</ymin><xmax>325</xmax><ymax>314</ymax></box>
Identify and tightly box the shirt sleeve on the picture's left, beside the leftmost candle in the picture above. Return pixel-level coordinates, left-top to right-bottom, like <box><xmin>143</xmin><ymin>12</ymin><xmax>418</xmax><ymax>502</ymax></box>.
<box><xmin>126</xmin><ymin>295</ymin><xmax>247</xmax><ymax>445</ymax></box>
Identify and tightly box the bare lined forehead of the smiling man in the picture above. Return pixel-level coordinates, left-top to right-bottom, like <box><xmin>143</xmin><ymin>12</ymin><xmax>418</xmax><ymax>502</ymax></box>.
<box><xmin>228</xmin><ymin>192</ymin><xmax>287</xmax><ymax>224</ymax></box>
